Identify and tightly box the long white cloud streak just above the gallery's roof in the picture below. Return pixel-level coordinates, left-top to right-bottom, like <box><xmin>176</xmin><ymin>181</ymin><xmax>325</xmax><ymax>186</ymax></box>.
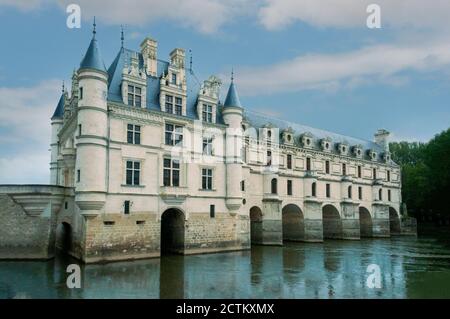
<box><xmin>237</xmin><ymin>43</ymin><xmax>450</xmax><ymax>95</ymax></box>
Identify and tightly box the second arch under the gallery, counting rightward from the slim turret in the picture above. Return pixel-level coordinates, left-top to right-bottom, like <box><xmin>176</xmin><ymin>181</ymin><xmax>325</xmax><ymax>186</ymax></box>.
<box><xmin>281</xmin><ymin>204</ymin><xmax>305</xmax><ymax>241</ymax></box>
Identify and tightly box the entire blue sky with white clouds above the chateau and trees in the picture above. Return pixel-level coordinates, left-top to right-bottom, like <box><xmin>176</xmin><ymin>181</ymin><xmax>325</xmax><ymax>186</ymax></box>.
<box><xmin>0</xmin><ymin>0</ymin><xmax>450</xmax><ymax>183</ymax></box>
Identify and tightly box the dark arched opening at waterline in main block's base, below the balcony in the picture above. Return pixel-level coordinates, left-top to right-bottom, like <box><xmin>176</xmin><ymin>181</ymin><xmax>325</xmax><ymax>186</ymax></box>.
<box><xmin>161</xmin><ymin>208</ymin><xmax>185</xmax><ymax>255</ymax></box>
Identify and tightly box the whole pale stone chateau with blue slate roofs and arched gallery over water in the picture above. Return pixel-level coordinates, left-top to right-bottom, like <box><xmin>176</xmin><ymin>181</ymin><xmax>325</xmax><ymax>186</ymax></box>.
<box><xmin>0</xmin><ymin>28</ymin><xmax>415</xmax><ymax>263</ymax></box>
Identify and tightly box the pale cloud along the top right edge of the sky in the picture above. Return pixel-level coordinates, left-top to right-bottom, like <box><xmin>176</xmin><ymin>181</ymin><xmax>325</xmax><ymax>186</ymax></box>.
<box><xmin>259</xmin><ymin>0</ymin><xmax>450</xmax><ymax>30</ymax></box>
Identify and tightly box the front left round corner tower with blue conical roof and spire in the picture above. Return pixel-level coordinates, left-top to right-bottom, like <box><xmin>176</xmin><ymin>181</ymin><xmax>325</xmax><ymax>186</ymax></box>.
<box><xmin>75</xmin><ymin>22</ymin><xmax>108</xmax><ymax>216</ymax></box>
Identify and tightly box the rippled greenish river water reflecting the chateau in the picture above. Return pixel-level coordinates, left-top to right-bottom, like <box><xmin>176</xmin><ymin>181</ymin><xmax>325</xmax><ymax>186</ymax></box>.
<box><xmin>0</xmin><ymin>232</ymin><xmax>450</xmax><ymax>298</ymax></box>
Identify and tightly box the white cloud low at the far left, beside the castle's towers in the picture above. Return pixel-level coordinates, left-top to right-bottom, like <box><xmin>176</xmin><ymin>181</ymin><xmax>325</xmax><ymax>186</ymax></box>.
<box><xmin>0</xmin><ymin>80</ymin><xmax>61</xmax><ymax>183</ymax></box>
